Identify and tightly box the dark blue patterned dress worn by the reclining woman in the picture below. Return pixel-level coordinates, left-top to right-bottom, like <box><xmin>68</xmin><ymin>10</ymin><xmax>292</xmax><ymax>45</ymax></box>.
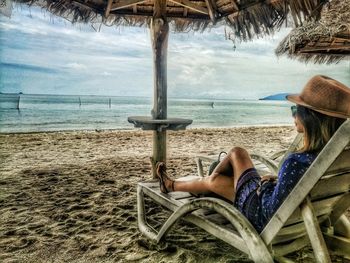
<box><xmin>234</xmin><ymin>152</ymin><xmax>316</xmax><ymax>232</ymax></box>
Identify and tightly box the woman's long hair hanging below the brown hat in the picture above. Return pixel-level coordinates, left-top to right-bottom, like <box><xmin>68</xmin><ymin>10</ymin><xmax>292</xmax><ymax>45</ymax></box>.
<box><xmin>297</xmin><ymin>105</ymin><xmax>345</xmax><ymax>153</ymax></box>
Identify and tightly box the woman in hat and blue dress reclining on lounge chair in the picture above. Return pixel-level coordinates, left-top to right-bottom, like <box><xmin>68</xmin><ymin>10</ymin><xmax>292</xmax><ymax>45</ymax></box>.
<box><xmin>157</xmin><ymin>75</ymin><xmax>350</xmax><ymax>232</ymax></box>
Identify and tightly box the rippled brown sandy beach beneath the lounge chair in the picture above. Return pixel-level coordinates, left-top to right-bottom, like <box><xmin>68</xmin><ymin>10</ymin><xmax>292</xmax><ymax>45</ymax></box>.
<box><xmin>0</xmin><ymin>126</ymin><xmax>344</xmax><ymax>262</ymax></box>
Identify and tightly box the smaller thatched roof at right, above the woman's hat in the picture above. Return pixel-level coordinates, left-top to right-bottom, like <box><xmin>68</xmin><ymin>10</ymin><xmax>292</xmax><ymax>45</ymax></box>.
<box><xmin>276</xmin><ymin>0</ymin><xmax>350</xmax><ymax>64</ymax></box>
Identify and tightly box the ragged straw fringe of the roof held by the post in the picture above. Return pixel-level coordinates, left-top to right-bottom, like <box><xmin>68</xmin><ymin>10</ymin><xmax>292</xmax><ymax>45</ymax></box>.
<box><xmin>14</xmin><ymin>0</ymin><xmax>328</xmax><ymax>40</ymax></box>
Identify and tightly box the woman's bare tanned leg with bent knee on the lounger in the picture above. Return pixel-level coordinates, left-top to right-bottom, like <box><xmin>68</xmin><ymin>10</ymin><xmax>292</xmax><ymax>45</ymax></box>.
<box><xmin>158</xmin><ymin>147</ymin><xmax>254</xmax><ymax>201</ymax></box>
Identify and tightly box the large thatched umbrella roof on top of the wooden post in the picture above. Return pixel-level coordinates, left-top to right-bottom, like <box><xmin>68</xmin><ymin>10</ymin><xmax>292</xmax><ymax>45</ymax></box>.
<box><xmin>14</xmin><ymin>0</ymin><xmax>327</xmax><ymax>40</ymax></box>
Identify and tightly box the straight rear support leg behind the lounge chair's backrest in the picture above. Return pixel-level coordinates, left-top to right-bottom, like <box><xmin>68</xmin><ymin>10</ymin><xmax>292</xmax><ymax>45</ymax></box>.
<box><xmin>300</xmin><ymin>197</ymin><xmax>331</xmax><ymax>263</ymax></box>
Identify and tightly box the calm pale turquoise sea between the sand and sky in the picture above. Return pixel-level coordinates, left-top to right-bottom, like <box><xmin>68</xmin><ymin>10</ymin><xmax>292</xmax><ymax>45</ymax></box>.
<box><xmin>0</xmin><ymin>94</ymin><xmax>292</xmax><ymax>133</ymax></box>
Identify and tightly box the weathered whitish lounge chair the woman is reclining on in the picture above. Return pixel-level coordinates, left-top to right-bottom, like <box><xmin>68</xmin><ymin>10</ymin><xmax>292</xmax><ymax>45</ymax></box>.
<box><xmin>137</xmin><ymin>119</ymin><xmax>350</xmax><ymax>262</ymax></box>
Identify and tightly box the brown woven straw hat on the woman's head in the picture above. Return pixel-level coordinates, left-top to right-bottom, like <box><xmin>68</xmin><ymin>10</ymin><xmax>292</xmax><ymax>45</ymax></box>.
<box><xmin>286</xmin><ymin>75</ymin><xmax>350</xmax><ymax>119</ymax></box>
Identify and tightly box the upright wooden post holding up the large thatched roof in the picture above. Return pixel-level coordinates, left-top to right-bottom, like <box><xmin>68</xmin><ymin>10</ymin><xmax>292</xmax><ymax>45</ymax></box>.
<box><xmin>150</xmin><ymin>0</ymin><xmax>169</xmax><ymax>178</ymax></box>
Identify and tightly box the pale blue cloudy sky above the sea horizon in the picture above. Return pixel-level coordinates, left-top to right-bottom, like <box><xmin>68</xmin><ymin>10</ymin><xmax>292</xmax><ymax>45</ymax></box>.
<box><xmin>0</xmin><ymin>6</ymin><xmax>350</xmax><ymax>99</ymax></box>
